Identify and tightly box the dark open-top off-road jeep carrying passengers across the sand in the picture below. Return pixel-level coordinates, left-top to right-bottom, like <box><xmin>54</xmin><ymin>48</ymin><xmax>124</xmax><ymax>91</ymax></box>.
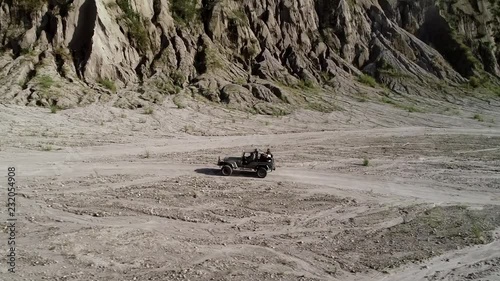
<box><xmin>217</xmin><ymin>152</ymin><xmax>276</xmax><ymax>178</ymax></box>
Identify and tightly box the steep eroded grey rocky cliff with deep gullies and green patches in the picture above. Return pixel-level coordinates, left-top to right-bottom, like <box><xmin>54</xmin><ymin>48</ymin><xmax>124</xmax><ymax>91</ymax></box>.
<box><xmin>0</xmin><ymin>0</ymin><xmax>500</xmax><ymax>113</ymax></box>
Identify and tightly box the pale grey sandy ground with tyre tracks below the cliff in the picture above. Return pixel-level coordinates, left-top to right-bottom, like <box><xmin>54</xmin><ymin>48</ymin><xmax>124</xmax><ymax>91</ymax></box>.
<box><xmin>0</xmin><ymin>95</ymin><xmax>500</xmax><ymax>281</ymax></box>
